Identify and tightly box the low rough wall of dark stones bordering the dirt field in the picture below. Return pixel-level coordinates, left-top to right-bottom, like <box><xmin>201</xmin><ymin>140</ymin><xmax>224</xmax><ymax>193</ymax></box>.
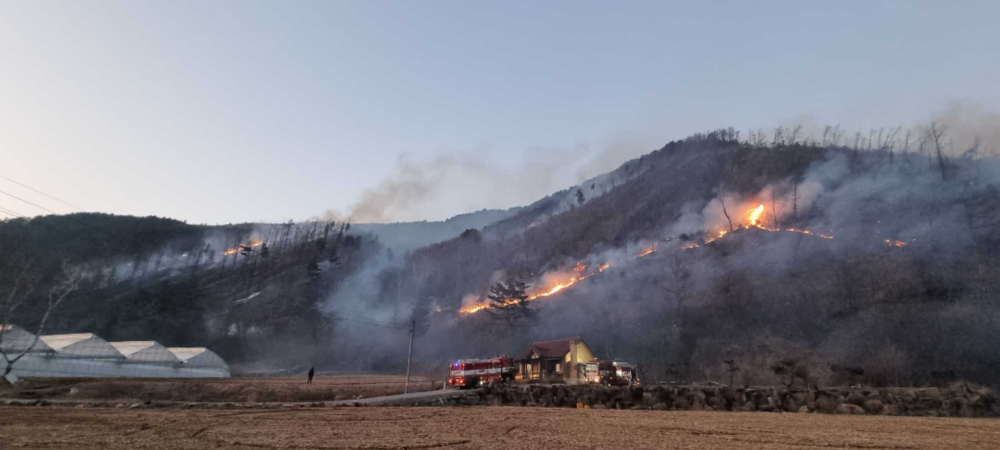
<box><xmin>427</xmin><ymin>384</ymin><xmax>1000</xmax><ymax>417</ymax></box>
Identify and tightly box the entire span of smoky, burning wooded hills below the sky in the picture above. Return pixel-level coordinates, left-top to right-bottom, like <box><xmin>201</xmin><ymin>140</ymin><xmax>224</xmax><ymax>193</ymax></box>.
<box><xmin>0</xmin><ymin>129</ymin><xmax>1000</xmax><ymax>385</ymax></box>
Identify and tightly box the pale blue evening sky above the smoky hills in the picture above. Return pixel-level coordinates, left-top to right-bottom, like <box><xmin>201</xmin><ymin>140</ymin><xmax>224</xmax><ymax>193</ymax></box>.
<box><xmin>0</xmin><ymin>0</ymin><xmax>1000</xmax><ymax>224</ymax></box>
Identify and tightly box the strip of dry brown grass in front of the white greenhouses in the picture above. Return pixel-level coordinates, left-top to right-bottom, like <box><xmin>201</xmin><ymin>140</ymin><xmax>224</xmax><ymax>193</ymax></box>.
<box><xmin>0</xmin><ymin>375</ymin><xmax>440</xmax><ymax>402</ymax></box>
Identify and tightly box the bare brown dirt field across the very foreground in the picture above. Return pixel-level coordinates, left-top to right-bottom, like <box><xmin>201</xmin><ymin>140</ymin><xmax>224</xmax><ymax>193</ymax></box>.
<box><xmin>0</xmin><ymin>407</ymin><xmax>1000</xmax><ymax>450</ymax></box>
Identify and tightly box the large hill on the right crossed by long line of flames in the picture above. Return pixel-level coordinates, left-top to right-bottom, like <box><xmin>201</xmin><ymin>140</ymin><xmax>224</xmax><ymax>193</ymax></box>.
<box><xmin>364</xmin><ymin>130</ymin><xmax>1000</xmax><ymax>385</ymax></box>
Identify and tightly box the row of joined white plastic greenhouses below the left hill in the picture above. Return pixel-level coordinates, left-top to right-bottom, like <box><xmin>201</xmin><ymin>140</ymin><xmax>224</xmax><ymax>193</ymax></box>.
<box><xmin>0</xmin><ymin>325</ymin><xmax>229</xmax><ymax>378</ymax></box>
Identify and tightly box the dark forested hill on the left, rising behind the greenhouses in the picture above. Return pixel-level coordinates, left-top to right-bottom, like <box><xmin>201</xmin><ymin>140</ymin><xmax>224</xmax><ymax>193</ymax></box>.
<box><xmin>0</xmin><ymin>213</ymin><xmax>382</xmax><ymax>367</ymax></box>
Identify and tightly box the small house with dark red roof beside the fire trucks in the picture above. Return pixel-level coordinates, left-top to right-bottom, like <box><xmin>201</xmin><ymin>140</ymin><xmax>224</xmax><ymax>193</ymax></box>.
<box><xmin>514</xmin><ymin>336</ymin><xmax>597</xmax><ymax>384</ymax></box>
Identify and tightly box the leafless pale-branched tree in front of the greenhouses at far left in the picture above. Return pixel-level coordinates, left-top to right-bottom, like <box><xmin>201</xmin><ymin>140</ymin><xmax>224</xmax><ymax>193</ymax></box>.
<box><xmin>0</xmin><ymin>261</ymin><xmax>83</xmax><ymax>377</ymax></box>
